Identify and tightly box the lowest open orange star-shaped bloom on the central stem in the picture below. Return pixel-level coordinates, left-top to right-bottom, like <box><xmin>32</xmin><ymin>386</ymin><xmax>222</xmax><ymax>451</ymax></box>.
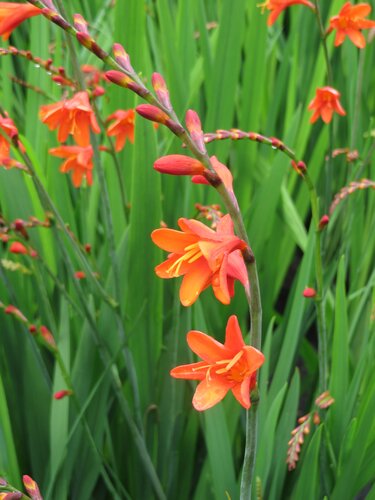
<box><xmin>171</xmin><ymin>315</ymin><xmax>264</xmax><ymax>411</ymax></box>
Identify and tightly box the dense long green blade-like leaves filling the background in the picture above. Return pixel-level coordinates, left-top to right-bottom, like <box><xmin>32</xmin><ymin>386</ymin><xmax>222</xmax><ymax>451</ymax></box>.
<box><xmin>0</xmin><ymin>0</ymin><xmax>375</xmax><ymax>500</ymax></box>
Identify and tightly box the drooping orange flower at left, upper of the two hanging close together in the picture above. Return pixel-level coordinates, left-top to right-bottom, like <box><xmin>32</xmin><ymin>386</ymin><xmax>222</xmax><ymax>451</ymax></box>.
<box><xmin>39</xmin><ymin>92</ymin><xmax>100</xmax><ymax>147</ymax></box>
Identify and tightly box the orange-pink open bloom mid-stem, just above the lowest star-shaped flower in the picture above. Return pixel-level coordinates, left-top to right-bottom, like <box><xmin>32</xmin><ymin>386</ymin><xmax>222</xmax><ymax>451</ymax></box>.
<box><xmin>151</xmin><ymin>215</ymin><xmax>249</xmax><ymax>306</ymax></box>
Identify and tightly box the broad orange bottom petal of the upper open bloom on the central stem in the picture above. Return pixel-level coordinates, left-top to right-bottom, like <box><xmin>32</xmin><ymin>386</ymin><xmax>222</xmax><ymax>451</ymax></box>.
<box><xmin>180</xmin><ymin>258</ymin><xmax>212</xmax><ymax>306</ymax></box>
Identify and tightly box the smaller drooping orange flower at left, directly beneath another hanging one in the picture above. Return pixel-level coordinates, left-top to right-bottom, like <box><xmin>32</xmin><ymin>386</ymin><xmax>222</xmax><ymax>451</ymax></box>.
<box><xmin>49</xmin><ymin>146</ymin><xmax>93</xmax><ymax>187</ymax></box>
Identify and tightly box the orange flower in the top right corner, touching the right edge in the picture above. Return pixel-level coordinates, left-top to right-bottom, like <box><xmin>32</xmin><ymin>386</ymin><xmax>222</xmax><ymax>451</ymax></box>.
<box><xmin>328</xmin><ymin>2</ymin><xmax>375</xmax><ymax>49</ymax></box>
